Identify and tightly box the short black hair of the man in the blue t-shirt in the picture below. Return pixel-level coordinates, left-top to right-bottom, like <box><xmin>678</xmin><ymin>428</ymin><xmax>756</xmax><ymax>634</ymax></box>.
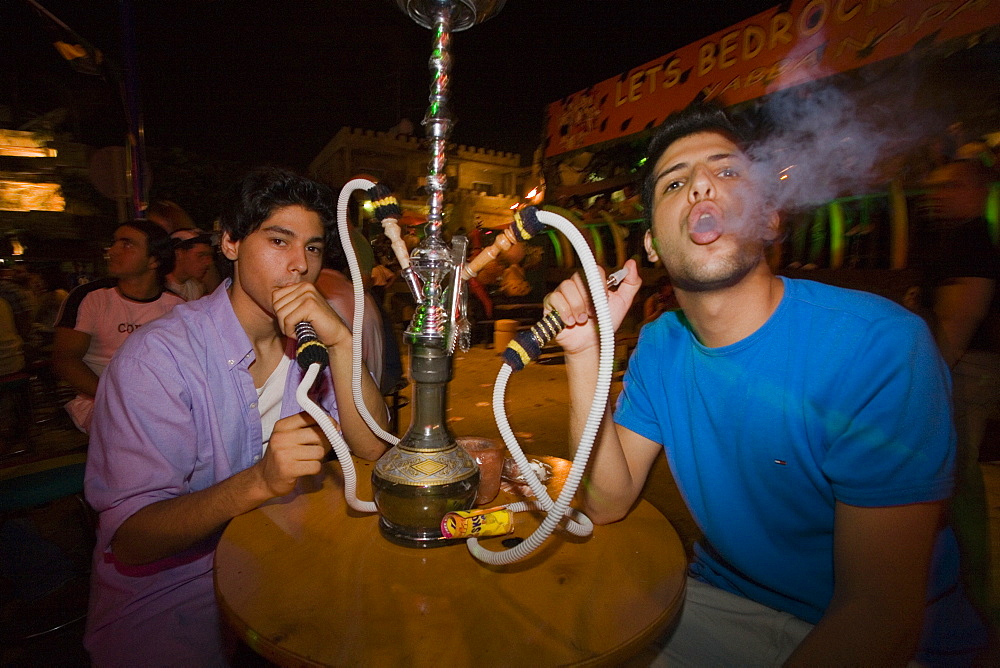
<box><xmin>642</xmin><ymin>102</ymin><xmax>750</xmax><ymax>229</ymax></box>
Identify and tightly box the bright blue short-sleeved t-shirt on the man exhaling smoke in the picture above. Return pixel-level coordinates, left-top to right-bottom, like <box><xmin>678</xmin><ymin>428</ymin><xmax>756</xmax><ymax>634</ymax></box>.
<box><xmin>615</xmin><ymin>278</ymin><xmax>984</xmax><ymax>656</ymax></box>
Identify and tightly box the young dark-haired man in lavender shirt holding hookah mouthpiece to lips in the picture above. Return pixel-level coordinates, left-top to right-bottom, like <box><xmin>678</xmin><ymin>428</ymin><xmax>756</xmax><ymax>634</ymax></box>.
<box><xmin>85</xmin><ymin>169</ymin><xmax>386</xmax><ymax>666</ymax></box>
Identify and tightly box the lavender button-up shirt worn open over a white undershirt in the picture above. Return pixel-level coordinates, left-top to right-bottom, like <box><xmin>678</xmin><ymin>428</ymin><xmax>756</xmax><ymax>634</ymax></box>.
<box><xmin>85</xmin><ymin>281</ymin><xmax>337</xmax><ymax>666</ymax></box>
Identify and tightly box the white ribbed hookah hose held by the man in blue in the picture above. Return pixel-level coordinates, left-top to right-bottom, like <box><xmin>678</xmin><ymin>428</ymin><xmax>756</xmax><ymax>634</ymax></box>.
<box><xmin>467</xmin><ymin>211</ymin><xmax>615</xmax><ymax>566</ymax></box>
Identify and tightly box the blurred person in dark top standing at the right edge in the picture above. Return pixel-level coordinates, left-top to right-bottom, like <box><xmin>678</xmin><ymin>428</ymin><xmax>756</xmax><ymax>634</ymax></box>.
<box><xmin>918</xmin><ymin>159</ymin><xmax>1000</xmax><ymax>622</ymax></box>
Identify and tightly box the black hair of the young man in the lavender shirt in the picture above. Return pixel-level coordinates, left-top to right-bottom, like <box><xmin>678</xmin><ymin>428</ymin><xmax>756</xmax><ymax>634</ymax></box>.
<box><xmin>219</xmin><ymin>167</ymin><xmax>337</xmax><ymax>244</ymax></box>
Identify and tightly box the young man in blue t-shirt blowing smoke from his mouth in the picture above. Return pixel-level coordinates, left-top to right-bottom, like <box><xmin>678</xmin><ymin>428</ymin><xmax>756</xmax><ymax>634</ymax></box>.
<box><xmin>545</xmin><ymin>105</ymin><xmax>984</xmax><ymax>666</ymax></box>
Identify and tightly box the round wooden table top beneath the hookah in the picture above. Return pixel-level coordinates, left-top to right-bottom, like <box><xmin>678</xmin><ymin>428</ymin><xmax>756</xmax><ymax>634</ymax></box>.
<box><xmin>215</xmin><ymin>460</ymin><xmax>686</xmax><ymax>668</ymax></box>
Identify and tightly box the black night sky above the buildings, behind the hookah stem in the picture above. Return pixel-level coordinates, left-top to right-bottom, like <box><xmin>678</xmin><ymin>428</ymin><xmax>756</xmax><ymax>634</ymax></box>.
<box><xmin>0</xmin><ymin>0</ymin><xmax>780</xmax><ymax>169</ymax></box>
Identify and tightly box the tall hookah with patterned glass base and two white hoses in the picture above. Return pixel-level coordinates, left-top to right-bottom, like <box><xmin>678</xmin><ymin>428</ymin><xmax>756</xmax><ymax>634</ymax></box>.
<box><xmin>296</xmin><ymin>0</ymin><xmax>624</xmax><ymax>565</ymax></box>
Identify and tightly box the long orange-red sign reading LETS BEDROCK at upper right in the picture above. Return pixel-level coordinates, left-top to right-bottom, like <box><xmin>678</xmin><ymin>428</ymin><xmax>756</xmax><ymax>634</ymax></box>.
<box><xmin>545</xmin><ymin>0</ymin><xmax>1000</xmax><ymax>157</ymax></box>
